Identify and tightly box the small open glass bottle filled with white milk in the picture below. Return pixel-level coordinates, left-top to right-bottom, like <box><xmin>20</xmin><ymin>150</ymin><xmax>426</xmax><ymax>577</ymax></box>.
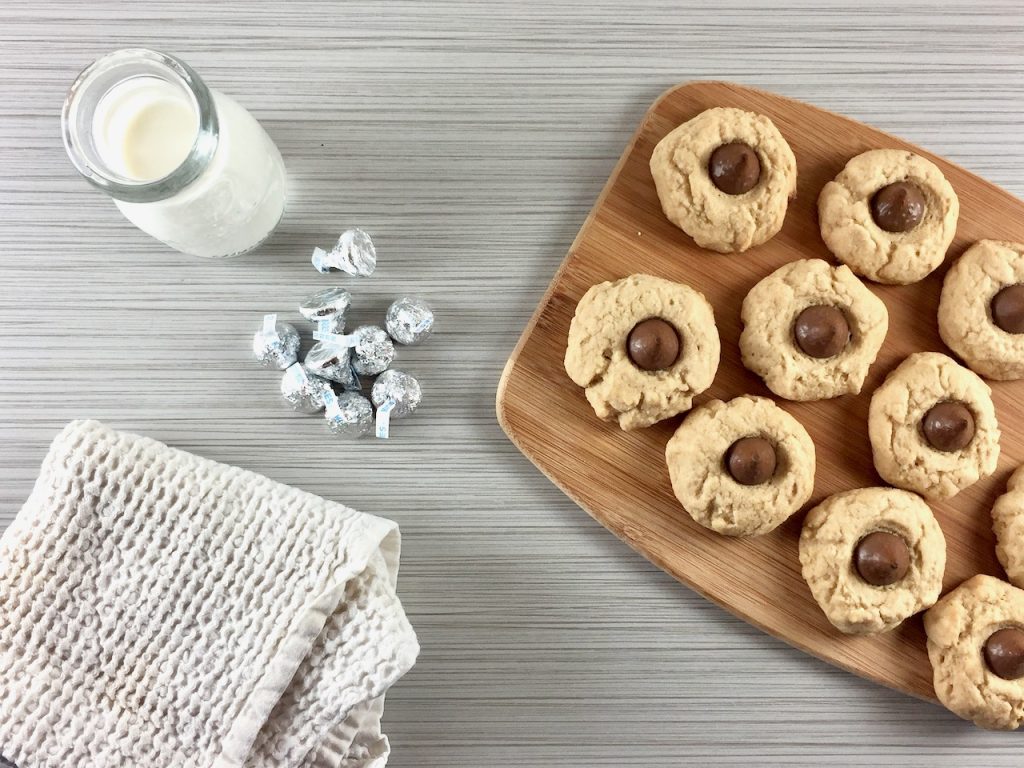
<box><xmin>60</xmin><ymin>48</ymin><xmax>285</xmax><ymax>258</ymax></box>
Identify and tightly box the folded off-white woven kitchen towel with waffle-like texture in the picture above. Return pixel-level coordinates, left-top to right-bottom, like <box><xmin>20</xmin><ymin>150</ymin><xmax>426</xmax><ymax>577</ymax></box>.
<box><xmin>0</xmin><ymin>422</ymin><xmax>419</xmax><ymax>768</ymax></box>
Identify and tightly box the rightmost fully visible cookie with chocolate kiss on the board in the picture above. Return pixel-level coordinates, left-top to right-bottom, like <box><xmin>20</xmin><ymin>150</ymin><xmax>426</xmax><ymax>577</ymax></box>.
<box><xmin>867</xmin><ymin>352</ymin><xmax>999</xmax><ymax>499</ymax></box>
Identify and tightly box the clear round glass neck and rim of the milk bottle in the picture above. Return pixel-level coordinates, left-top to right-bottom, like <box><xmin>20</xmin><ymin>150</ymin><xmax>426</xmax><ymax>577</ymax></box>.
<box><xmin>60</xmin><ymin>48</ymin><xmax>218</xmax><ymax>203</ymax></box>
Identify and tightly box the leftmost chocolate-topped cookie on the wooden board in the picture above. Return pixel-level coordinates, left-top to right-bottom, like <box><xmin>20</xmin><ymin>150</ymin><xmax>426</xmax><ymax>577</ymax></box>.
<box><xmin>565</xmin><ymin>274</ymin><xmax>720</xmax><ymax>429</ymax></box>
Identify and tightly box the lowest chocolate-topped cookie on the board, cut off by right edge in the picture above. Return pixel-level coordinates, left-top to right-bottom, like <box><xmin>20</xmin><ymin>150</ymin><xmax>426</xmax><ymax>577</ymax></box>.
<box><xmin>925</xmin><ymin>575</ymin><xmax>1024</xmax><ymax>730</ymax></box>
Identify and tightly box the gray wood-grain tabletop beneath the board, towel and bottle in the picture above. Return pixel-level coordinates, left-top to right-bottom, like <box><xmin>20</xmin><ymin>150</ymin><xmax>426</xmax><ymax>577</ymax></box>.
<box><xmin>0</xmin><ymin>0</ymin><xmax>1024</xmax><ymax>768</ymax></box>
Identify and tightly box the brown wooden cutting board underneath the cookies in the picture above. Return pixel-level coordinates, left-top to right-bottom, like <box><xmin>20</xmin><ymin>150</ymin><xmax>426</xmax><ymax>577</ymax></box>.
<box><xmin>498</xmin><ymin>82</ymin><xmax>1024</xmax><ymax>699</ymax></box>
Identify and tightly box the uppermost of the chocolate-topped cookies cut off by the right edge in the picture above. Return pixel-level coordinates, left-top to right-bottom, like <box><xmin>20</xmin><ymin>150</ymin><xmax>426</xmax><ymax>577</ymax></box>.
<box><xmin>939</xmin><ymin>240</ymin><xmax>1024</xmax><ymax>381</ymax></box>
